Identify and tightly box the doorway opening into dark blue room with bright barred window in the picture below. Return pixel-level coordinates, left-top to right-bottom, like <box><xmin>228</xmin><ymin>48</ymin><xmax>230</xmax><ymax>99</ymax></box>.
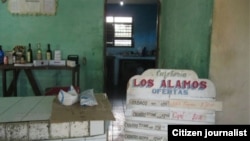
<box><xmin>104</xmin><ymin>0</ymin><xmax>160</xmax><ymax>91</ymax></box>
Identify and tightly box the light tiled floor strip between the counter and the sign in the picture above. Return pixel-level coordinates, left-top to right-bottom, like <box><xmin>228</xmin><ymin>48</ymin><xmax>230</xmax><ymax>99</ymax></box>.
<box><xmin>107</xmin><ymin>87</ymin><xmax>126</xmax><ymax>141</ymax></box>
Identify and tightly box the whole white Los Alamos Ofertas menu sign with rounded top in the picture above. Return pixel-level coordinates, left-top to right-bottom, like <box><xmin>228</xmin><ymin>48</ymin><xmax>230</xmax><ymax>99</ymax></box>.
<box><xmin>124</xmin><ymin>69</ymin><xmax>222</xmax><ymax>141</ymax></box>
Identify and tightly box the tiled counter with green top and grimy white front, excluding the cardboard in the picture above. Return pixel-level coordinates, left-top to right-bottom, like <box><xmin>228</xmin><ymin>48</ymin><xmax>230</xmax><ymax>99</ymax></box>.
<box><xmin>0</xmin><ymin>95</ymin><xmax>109</xmax><ymax>141</ymax></box>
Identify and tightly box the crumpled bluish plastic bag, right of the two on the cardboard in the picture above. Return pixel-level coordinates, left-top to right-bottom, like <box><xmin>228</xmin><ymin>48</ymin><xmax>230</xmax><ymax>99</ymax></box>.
<box><xmin>80</xmin><ymin>89</ymin><xmax>98</xmax><ymax>106</ymax></box>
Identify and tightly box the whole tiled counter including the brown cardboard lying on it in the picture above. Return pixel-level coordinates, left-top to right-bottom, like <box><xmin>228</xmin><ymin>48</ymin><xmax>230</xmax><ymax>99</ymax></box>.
<box><xmin>0</xmin><ymin>94</ymin><xmax>114</xmax><ymax>141</ymax></box>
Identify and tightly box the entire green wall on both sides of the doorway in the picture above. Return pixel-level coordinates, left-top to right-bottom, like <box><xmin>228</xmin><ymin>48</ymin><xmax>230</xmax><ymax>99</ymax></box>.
<box><xmin>0</xmin><ymin>0</ymin><xmax>213</xmax><ymax>96</ymax></box>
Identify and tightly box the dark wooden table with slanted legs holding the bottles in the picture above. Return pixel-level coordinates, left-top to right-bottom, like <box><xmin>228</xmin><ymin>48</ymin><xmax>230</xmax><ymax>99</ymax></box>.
<box><xmin>0</xmin><ymin>65</ymin><xmax>80</xmax><ymax>97</ymax></box>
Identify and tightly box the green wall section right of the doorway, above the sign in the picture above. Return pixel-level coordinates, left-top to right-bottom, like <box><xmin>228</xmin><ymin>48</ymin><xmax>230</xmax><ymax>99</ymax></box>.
<box><xmin>158</xmin><ymin>0</ymin><xmax>213</xmax><ymax>78</ymax></box>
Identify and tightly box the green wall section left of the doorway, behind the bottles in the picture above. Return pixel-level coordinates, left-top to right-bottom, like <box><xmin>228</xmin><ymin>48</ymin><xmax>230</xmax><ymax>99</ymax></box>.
<box><xmin>0</xmin><ymin>0</ymin><xmax>104</xmax><ymax>96</ymax></box>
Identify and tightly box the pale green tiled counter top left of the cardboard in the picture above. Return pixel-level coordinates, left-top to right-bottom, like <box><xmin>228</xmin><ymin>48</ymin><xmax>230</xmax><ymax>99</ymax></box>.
<box><xmin>0</xmin><ymin>96</ymin><xmax>55</xmax><ymax>123</ymax></box>
